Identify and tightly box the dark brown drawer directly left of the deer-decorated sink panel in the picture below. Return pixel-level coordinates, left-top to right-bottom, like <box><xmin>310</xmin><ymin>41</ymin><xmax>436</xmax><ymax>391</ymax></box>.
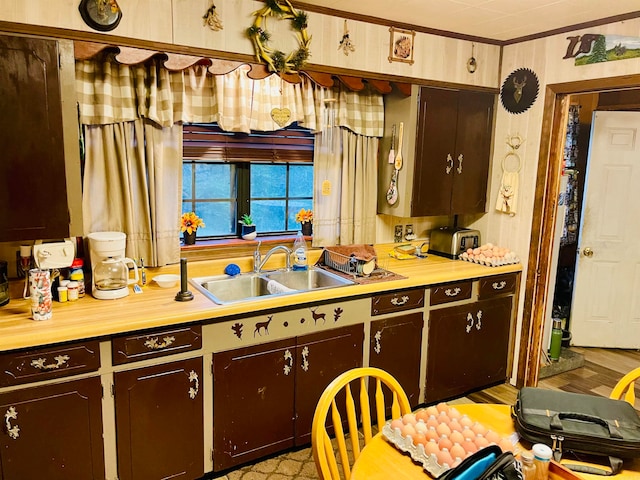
<box><xmin>111</xmin><ymin>325</ymin><xmax>202</xmax><ymax>365</ymax></box>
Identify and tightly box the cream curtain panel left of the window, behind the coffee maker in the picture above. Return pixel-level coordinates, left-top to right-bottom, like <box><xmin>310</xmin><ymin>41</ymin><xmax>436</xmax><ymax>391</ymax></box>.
<box><xmin>82</xmin><ymin>119</ymin><xmax>182</xmax><ymax>266</ymax></box>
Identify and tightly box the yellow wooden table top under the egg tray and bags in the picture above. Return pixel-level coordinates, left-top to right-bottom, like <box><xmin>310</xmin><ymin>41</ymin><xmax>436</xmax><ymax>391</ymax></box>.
<box><xmin>351</xmin><ymin>403</ymin><xmax>640</xmax><ymax>480</ymax></box>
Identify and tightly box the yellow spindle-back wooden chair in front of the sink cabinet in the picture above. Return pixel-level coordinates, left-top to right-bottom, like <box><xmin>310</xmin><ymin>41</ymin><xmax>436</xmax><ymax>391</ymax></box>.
<box><xmin>311</xmin><ymin>367</ymin><xmax>411</xmax><ymax>480</ymax></box>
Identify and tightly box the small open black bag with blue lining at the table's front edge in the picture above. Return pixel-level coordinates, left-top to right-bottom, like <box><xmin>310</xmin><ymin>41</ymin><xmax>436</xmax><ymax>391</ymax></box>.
<box><xmin>437</xmin><ymin>445</ymin><xmax>523</xmax><ymax>480</ymax></box>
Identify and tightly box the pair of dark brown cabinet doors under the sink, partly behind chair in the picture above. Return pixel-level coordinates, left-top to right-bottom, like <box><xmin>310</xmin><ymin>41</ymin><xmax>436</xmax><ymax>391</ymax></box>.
<box><xmin>213</xmin><ymin>325</ymin><xmax>364</xmax><ymax>471</ymax></box>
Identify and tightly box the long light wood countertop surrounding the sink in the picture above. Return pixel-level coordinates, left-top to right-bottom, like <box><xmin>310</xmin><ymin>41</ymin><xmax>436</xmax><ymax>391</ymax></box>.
<box><xmin>0</xmin><ymin>245</ymin><xmax>522</xmax><ymax>350</ymax></box>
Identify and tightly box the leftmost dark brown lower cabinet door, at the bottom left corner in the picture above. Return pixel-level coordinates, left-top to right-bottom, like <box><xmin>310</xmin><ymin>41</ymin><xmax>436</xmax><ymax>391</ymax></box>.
<box><xmin>0</xmin><ymin>377</ymin><xmax>105</xmax><ymax>480</ymax></box>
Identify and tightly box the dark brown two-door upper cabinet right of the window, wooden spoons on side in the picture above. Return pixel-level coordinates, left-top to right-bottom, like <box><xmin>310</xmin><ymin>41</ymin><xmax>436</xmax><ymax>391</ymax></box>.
<box><xmin>378</xmin><ymin>85</ymin><xmax>495</xmax><ymax>217</ymax></box>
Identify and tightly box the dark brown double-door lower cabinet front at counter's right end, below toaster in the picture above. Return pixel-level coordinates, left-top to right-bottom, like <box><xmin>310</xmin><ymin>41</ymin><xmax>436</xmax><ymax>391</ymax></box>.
<box><xmin>425</xmin><ymin>297</ymin><xmax>512</xmax><ymax>403</ymax></box>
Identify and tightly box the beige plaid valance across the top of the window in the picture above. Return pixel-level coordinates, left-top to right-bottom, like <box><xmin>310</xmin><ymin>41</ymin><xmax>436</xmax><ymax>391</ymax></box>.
<box><xmin>76</xmin><ymin>54</ymin><xmax>384</xmax><ymax>137</ymax></box>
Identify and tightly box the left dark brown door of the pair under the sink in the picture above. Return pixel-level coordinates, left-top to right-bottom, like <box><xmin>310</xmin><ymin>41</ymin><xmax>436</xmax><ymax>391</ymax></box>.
<box><xmin>213</xmin><ymin>339</ymin><xmax>296</xmax><ymax>471</ymax></box>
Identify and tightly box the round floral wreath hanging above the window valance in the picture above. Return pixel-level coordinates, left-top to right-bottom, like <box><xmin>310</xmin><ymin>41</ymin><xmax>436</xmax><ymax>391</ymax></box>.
<box><xmin>247</xmin><ymin>0</ymin><xmax>311</xmax><ymax>73</ymax></box>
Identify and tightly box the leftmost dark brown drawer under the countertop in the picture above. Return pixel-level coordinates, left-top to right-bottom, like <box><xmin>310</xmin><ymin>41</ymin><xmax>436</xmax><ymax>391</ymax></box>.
<box><xmin>0</xmin><ymin>340</ymin><xmax>100</xmax><ymax>387</ymax></box>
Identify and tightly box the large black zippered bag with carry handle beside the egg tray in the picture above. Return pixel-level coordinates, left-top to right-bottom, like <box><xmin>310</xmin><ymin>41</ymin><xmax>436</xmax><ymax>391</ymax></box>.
<box><xmin>511</xmin><ymin>387</ymin><xmax>640</xmax><ymax>475</ymax></box>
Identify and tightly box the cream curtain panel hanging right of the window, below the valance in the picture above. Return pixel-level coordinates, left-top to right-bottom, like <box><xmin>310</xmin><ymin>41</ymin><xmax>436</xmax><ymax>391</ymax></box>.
<box><xmin>313</xmin><ymin>127</ymin><xmax>379</xmax><ymax>246</ymax></box>
